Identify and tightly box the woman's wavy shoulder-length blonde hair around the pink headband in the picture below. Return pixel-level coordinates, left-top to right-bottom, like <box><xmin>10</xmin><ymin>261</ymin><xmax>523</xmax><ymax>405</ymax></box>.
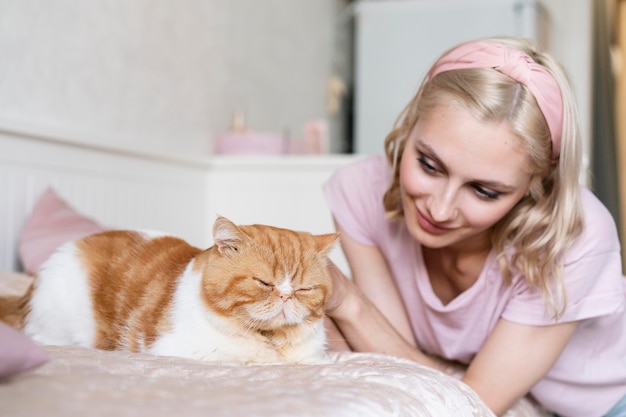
<box><xmin>383</xmin><ymin>38</ymin><xmax>584</xmax><ymax>318</ymax></box>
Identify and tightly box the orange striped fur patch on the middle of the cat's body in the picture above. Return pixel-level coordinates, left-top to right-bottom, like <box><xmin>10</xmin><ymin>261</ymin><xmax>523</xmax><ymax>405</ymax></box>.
<box><xmin>77</xmin><ymin>231</ymin><xmax>201</xmax><ymax>352</ymax></box>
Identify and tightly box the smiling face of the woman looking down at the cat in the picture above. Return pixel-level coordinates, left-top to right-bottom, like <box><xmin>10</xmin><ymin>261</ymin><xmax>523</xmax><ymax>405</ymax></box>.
<box><xmin>400</xmin><ymin>105</ymin><xmax>530</xmax><ymax>249</ymax></box>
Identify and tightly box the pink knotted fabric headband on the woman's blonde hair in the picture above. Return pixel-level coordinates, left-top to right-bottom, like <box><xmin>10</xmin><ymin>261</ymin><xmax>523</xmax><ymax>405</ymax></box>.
<box><xmin>429</xmin><ymin>41</ymin><xmax>563</xmax><ymax>159</ymax></box>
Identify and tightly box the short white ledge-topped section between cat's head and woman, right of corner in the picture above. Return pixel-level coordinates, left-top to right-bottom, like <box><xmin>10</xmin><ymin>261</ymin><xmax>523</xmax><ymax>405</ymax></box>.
<box><xmin>206</xmin><ymin>155</ymin><xmax>359</xmax><ymax>272</ymax></box>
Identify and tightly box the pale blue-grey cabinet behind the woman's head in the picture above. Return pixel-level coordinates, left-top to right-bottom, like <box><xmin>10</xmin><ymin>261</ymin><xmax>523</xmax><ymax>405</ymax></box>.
<box><xmin>355</xmin><ymin>0</ymin><xmax>538</xmax><ymax>154</ymax></box>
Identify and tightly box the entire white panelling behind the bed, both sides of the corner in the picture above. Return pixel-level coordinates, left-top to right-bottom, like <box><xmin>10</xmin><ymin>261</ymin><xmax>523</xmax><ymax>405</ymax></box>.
<box><xmin>0</xmin><ymin>121</ymin><xmax>360</xmax><ymax>272</ymax></box>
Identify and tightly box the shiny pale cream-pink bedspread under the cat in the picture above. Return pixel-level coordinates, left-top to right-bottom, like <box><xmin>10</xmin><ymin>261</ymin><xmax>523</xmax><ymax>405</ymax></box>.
<box><xmin>0</xmin><ymin>346</ymin><xmax>541</xmax><ymax>417</ymax></box>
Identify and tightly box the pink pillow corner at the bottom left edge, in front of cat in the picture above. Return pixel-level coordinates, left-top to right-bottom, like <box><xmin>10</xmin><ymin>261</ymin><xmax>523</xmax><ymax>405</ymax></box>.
<box><xmin>0</xmin><ymin>322</ymin><xmax>50</xmax><ymax>379</ymax></box>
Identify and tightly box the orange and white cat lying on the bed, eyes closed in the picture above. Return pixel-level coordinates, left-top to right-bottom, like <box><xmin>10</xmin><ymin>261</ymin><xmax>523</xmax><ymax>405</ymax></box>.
<box><xmin>24</xmin><ymin>217</ymin><xmax>338</xmax><ymax>364</ymax></box>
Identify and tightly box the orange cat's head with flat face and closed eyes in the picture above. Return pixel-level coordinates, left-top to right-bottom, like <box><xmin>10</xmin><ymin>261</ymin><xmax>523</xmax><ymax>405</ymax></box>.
<box><xmin>202</xmin><ymin>217</ymin><xmax>339</xmax><ymax>330</ymax></box>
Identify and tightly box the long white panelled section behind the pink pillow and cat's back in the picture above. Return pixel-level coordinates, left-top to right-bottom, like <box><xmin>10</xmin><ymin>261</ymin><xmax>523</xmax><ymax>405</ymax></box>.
<box><xmin>0</xmin><ymin>130</ymin><xmax>214</xmax><ymax>271</ymax></box>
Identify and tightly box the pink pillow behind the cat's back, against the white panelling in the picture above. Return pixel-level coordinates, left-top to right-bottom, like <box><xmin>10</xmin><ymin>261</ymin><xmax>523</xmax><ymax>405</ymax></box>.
<box><xmin>19</xmin><ymin>188</ymin><xmax>104</xmax><ymax>275</ymax></box>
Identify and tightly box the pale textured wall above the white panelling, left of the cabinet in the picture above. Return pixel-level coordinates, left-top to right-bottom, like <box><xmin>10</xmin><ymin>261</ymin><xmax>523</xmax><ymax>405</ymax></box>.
<box><xmin>0</xmin><ymin>0</ymin><xmax>341</xmax><ymax>153</ymax></box>
